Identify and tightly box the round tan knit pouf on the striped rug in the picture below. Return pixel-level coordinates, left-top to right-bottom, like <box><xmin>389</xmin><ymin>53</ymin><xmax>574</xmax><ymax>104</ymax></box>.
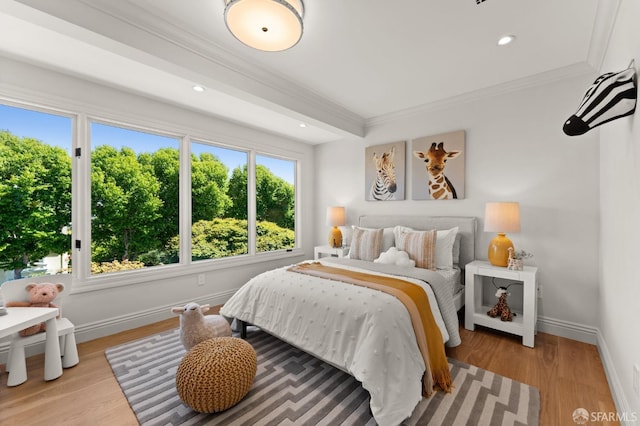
<box><xmin>176</xmin><ymin>337</ymin><xmax>258</xmax><ymax>413</ymax></box>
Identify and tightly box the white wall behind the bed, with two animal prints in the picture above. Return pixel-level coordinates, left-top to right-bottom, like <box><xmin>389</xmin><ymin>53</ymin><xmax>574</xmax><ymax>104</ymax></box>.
<box><xmin>316</xmin><ymin>74</ymin><xmax>599</xmax><ymax>343</ymax></box>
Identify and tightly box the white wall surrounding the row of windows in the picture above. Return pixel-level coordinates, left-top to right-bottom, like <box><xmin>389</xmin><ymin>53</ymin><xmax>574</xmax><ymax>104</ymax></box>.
<box><xmin>0</xmin><ymin>57</ymin><xmax>314</xmax><ymax>346</ymax></box>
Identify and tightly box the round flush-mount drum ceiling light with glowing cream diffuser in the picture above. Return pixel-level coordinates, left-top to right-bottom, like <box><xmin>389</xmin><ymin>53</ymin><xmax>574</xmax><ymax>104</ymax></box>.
<box><xmin>224</xmin><ymin>0</ymin><xmax>304</xmax><ymax>52</ymax></box>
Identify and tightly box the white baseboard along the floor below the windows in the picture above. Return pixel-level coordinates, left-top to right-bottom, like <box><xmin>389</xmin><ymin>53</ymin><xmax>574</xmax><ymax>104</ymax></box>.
<box><xmin>0</xmin><ymin>289</ymin><xmax>237</xmax><ymax>364</ymax></box>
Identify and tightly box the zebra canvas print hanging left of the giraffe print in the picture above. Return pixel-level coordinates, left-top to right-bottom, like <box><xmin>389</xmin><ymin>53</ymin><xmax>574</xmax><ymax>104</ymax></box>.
<box><xmin>365</xmin><ymin>142</ymin><xmax>405</xmax><ymax>201</ymax></box>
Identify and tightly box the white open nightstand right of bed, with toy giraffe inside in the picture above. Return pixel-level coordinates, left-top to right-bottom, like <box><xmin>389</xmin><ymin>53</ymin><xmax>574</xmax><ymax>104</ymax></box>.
<box><xmin>464</xmin><ymin>260</ymin><xmax>538</xmax><ymax>348</ymax></box>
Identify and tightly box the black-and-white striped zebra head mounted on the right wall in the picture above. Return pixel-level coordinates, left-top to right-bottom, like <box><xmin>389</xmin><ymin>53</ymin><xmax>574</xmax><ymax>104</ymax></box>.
<box><xmin>562</xmin><ymin>61</ymin><xmax>637</xmax><ymax>136</ymax></box>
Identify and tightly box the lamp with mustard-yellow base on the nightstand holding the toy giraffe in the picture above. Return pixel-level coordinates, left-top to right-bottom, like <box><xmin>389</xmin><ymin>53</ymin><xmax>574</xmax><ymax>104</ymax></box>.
<box><xmin>484</xmin><ymin>202</ymin><xmax>520</xmax><ymax>266</ymax></box>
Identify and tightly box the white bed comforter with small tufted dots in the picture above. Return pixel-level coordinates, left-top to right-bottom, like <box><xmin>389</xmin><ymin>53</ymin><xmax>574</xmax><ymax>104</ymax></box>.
<box><xmin>220</xmin><ymin>262</ymin><xmax>457</xmax><ymax>426</ymax></box>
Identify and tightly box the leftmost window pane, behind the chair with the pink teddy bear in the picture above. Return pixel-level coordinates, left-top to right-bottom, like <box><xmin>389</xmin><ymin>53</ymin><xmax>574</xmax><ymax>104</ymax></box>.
<box><xmin>0</xmin><ymin>105</ymin><xmax>73</xmax><ymax>281</ymax></box>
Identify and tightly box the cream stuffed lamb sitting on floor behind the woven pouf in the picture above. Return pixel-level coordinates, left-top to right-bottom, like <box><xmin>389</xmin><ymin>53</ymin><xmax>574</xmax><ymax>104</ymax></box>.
<box><xmin>171</xmin><ymin>302</ymin><xmax>231</xmax><ymax>351</ymax></box>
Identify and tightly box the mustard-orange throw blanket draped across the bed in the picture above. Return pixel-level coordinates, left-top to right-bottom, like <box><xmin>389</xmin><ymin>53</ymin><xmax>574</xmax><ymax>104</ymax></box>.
<box><xmin>288</xmin><ymin>262</ymin><xmax>453</xmax><ymax>397</ymax></box>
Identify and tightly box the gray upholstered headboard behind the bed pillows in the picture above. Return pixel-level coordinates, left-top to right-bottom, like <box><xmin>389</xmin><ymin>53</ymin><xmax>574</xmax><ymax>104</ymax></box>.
<box><xmin>358</xmin><ymin>215</ymin><xmax>476</xmax><ymax>269</ymax></box>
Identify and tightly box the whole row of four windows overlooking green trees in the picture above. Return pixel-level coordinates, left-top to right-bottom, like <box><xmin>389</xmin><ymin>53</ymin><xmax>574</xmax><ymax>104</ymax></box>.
<box><xmin>0</xmin><ymin>104</ymin><xmax>298</xmax><ymax>285</ymax></box>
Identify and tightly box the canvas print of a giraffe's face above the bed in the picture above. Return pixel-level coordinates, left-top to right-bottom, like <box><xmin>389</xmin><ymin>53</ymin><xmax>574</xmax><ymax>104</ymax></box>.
<box><xmin>413</xmin><ymin>131</ymin><xmax>464</xmax><ymax>200</ymax></box>
